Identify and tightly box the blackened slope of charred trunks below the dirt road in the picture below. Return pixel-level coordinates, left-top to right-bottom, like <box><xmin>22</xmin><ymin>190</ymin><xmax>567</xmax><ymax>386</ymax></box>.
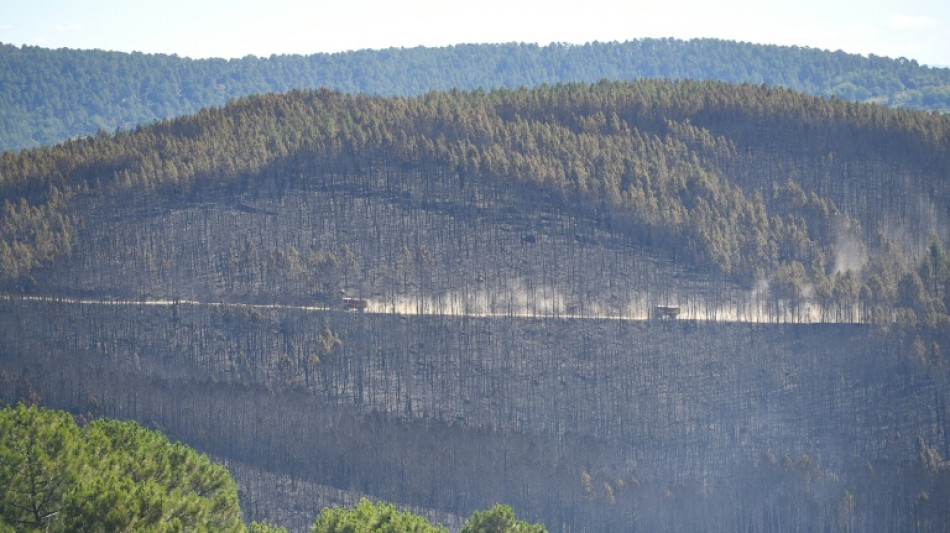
<box><xmin>0</xmin><ymin>301</ymin><xmax>950</xmax><ymax>531</ymax></box>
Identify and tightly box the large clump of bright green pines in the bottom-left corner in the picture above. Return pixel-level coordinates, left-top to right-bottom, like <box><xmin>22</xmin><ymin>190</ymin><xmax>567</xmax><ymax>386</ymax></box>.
<box><xmin>0</xmin><ymin>405</ymin><xmax>244</xmax><ymax>532</ymax></box>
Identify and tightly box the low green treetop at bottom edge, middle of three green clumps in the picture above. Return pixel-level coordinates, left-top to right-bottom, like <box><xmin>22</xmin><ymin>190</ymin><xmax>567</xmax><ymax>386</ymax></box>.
<box><xmin>310</xmin><ymin>498</ymin><xmax>447</xmax><ymax>533</ymax></box>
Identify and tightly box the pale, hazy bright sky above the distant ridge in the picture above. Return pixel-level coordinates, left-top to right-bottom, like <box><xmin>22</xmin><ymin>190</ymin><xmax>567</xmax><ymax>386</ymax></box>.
<box><xmin>0</xmin><ymin>0</ymin><xmax>950</xmax><ymax>66</ymax></box>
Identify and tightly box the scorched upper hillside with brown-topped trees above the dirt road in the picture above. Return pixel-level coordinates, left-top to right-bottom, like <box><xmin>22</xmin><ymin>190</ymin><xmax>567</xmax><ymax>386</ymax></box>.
<box><xmin>0</xmin><ymin>81</ymin><xmax>950</xmax><ymax>327</ymax></box>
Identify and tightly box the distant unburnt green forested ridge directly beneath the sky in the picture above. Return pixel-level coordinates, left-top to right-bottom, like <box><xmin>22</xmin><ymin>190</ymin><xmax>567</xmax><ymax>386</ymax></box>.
<box><xmin>0</xmin><ymin>39</ymin><xmax>950</xmax><ymax>150</ymax></box>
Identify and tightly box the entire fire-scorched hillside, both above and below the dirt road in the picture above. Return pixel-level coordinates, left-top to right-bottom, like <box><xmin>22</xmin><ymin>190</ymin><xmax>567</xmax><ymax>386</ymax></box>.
<box><xmin>0</xmin><ymin>80</ymin><xmax>950</xmax><ymax>531</ymax></box>
